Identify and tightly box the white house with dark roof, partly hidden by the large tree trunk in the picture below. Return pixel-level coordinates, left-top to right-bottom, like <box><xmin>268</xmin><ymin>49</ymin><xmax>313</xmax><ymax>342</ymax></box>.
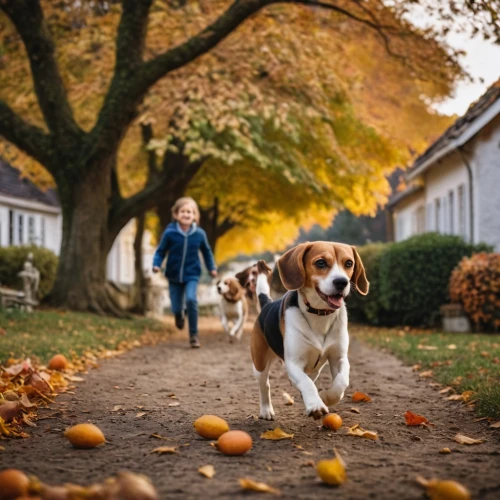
<box><xmin>0</xmin><ymin>158</ymin><xmax>155</xmax><ymax>285</ymax></box>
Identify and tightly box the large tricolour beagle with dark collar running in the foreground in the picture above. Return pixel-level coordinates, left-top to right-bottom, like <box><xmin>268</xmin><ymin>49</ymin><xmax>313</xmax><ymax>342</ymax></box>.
<box><xmin>251</xmin><ymin>241</ymin><xmax>369</xmax><ymax>420</ymax></box>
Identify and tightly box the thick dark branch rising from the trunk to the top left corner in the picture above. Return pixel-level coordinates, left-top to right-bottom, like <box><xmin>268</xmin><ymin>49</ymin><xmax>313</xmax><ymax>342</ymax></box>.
<box><xmin>0</xmin><ymin>0</ymin><xmax>81</xmax><ymax>138</ymax></box>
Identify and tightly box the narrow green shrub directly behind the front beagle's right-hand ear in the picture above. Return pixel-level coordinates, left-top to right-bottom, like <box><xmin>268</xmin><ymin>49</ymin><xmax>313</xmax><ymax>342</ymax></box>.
<box><xmin>347</xmin><ymin>243</ymin><xmax>390</xmax><ymax>325</ymax></box>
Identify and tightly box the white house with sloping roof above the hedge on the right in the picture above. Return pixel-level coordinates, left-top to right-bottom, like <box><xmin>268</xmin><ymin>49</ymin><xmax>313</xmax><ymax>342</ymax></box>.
<box><xmin>388</xmin><ymin>80</ymin><xmax>500</xmax><ymax>252</ymax></box>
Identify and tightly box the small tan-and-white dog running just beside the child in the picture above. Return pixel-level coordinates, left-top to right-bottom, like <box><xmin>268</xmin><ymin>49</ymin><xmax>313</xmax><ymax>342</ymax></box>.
<box><xmin>217</xmin><ymin>278</ymin><xmax>248</xmax><ymax>342</ymax></box>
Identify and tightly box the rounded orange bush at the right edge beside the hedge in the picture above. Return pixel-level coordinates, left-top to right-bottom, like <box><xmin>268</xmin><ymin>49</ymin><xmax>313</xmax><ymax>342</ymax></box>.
<box><xmin>450</xmin><ymin>253</ymin><xmax>500</xmax><ymax>331</ymax></box>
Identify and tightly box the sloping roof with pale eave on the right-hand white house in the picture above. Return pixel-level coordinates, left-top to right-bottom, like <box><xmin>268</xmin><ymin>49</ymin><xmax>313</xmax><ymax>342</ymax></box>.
<box><xmin>406</xmin><ymin>79</ymin><xmax>500</xmax><ymax>180</ymax></box>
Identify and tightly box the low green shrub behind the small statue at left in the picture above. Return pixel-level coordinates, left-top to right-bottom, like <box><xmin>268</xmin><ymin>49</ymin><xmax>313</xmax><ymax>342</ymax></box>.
<box><xmin>0</xmin><ymin>245</ymin><xmax>58</xmax><ymax>300</ymax></box>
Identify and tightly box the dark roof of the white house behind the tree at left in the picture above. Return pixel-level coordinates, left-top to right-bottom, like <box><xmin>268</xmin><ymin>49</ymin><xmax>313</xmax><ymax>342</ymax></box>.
<box><xmin>0</xmin><ymin>158</ymin><xmax>60</xmax><ymax>207</ymax></box>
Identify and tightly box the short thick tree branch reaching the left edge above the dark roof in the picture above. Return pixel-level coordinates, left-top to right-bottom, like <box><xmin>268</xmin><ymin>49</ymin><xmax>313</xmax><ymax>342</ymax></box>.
<box><xmin>0</xmin><ymin>101</ymin><xmax>52</xmax><ymax>166</ymax></box>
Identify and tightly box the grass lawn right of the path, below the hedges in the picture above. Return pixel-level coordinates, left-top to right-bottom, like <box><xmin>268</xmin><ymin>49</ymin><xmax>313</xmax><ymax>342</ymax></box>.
<box><xmin>350</xmin><ymin>325</ymin><xmax>500</xmax><ymax>419</ymax></box>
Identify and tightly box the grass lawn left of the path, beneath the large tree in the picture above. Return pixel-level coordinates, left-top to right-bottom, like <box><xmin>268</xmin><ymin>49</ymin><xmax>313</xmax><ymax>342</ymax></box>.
<box><xmin>0</xmin><ymin>310</ymin><xmax>169</xmax><ymax>365</ymax></box>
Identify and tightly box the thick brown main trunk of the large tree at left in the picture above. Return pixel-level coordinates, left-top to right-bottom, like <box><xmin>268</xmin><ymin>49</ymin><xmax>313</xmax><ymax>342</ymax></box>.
<box><xmin>47</xmin><ymin>164</ymin><xmax>120</xmax><ymax>315</ymax></box>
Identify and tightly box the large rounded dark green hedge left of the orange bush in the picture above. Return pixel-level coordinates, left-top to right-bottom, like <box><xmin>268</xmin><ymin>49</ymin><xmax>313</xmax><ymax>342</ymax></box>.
<box><xmin>379</xmin><ymin>233</ymin><xmax>491</xmax><ymax>325</ymax></box>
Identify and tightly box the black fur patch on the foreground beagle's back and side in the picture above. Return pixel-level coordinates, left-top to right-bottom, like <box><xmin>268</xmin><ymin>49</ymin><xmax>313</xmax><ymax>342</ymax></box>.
<box><xmin>258</xmin><ymin>291</ymin><xmax>299</xmax><ymax>359</ymax></box>
